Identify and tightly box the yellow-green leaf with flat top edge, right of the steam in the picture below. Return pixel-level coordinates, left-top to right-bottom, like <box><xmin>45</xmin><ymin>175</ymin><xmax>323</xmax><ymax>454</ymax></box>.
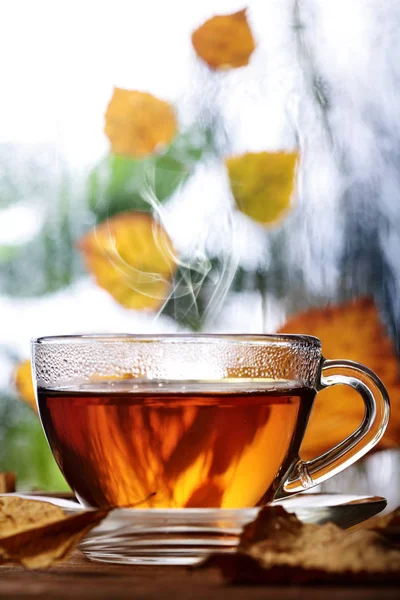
<box><xmin>225</xmin><ymin>152</ymin><xmax>298</xmax><ymax>226</ymax></box>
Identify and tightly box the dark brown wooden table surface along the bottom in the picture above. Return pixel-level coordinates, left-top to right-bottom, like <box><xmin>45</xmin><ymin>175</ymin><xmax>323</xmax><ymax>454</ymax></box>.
<box><xmin>0</xmin><ymin>551</ymin><xmax>399</xmax><ymax>600</ymax></box>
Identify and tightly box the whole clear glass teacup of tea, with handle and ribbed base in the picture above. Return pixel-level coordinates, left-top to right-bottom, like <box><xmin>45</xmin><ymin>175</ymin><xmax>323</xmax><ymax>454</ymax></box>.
<box><xmin>32</xmin><ymin>334</ymin><xmax>390</xmax><ymax>564</ymax></box>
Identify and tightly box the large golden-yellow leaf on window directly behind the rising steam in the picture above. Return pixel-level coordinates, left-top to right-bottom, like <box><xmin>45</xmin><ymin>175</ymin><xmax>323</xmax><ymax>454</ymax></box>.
<box><xmin>78</xmin><ymin>211</ymin><xmax>176</xmax><ymax>310</ymax></box>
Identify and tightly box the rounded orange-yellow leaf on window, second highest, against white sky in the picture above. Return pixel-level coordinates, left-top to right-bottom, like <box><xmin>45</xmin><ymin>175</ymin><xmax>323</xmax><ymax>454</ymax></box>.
<box><xmin>104</xmin><ymin>87</ymin><xmax>177</xmax><ymax>158</ymax></box>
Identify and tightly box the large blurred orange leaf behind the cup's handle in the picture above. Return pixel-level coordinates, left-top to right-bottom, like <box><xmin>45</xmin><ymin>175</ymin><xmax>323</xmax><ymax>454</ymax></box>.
<box><xmin>280</xmin><ymin>298</ymin><xmax>400</xmax><ymax>459</ymax></box>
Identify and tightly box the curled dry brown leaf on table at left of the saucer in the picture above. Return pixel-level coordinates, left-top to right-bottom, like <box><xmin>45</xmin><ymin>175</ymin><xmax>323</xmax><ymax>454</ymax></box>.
<box><xmin>0</xmin><ymin>496</ymin><xmax>110</xmax><ymax>569</ymax></box>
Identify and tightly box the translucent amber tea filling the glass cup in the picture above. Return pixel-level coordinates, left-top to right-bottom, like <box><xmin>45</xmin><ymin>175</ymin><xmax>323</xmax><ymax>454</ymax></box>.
<box><xmin>39</xmin><ymin>380</ymin><xmax>315</xmax><ymax>508</ymax></box>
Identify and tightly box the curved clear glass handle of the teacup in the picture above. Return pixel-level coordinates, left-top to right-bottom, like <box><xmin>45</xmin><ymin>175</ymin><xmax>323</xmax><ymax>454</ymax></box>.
<box><xmin>275</xmin><ymin>360</ymin><xmax>390</xmax><ymax>500</ymax></box>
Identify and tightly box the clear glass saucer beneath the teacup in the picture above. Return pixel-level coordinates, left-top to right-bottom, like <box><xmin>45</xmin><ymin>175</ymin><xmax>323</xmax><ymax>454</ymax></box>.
<box><xmin>7</xmin><ymin>493</ymin><xmax>386</xmax><ymax>565</ymax></box>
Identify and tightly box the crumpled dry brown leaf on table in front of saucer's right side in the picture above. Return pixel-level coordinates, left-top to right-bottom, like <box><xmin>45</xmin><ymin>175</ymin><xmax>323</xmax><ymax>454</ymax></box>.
<box><xmin>201</xmin><ymin>507</ymin><xmax>400</xmax><ymax>584</ymax></box>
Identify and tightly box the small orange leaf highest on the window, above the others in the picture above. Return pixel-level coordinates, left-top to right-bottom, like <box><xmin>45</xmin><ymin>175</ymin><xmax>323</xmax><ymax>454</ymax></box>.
<box><xmin>192</xmin><ymin>9</ymin><xmax>256</xmax><ymax>69</ymax></box>
